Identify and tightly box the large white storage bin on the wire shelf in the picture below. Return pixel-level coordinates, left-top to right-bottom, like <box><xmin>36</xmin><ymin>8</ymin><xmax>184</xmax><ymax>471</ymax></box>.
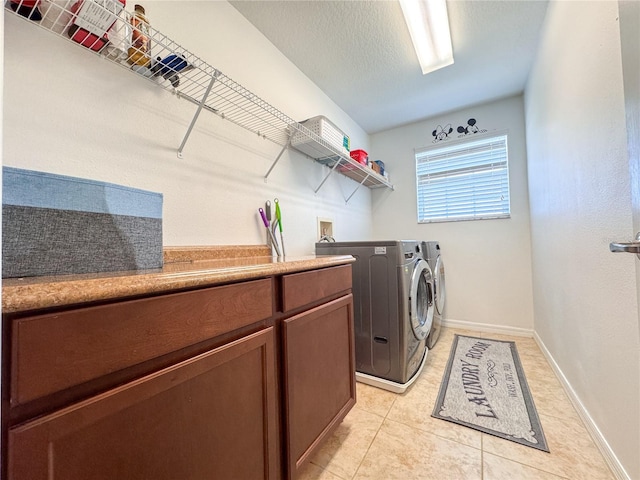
<box><xmin>291</xmin><ymin>115</ymin><xmax>349</xmax><ymax>159</ymax></box>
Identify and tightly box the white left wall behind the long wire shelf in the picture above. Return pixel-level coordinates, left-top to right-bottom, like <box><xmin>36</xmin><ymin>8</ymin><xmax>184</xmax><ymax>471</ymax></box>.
<box><xmin>3</xmin><ymin>1</ymin><xmax>371</xmax><ymax>255</ymax></box>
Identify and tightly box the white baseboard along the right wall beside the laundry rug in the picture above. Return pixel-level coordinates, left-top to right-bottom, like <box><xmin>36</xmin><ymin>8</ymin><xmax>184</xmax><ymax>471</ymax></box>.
<box><xmin>533</xmin><ymin>332</ymin><xmax>631</xmax><ymax>480</ymax></box>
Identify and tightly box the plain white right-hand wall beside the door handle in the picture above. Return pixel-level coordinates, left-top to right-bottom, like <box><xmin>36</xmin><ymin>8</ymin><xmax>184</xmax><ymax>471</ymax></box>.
<box><xmin>525</xmin><ymin>1</ymin><xmax>640</xmax><ymax>479</ymax></box>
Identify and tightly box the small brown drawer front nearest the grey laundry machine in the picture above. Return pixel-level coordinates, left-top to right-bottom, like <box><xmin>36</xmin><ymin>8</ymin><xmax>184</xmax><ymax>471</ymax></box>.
<box><xmin>282</xmin><ymin>265</ymin><xmax>352</xmax><ymax>312</ymax></box>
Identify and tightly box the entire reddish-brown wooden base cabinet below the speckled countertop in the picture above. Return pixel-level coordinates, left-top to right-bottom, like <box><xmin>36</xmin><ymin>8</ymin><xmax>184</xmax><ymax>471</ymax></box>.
<box><xmin>2</xmin><ymin>265</ymin><xmax>355</xmax><ymax>480</ymax></box>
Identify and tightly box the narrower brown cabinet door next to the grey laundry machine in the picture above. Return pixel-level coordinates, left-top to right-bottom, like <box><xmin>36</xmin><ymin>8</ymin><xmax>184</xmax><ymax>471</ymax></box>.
<box><xmin>283</xmin><ymin>294</ymin><xmax>356</xmax><ymax>478</ymax></box>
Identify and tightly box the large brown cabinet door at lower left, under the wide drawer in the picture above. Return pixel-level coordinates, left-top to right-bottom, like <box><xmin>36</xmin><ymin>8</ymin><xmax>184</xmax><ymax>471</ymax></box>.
<box><xmin>8</xmin><ymin>328</ymin><xmax>279</xmax><ymax>480</ymax></box>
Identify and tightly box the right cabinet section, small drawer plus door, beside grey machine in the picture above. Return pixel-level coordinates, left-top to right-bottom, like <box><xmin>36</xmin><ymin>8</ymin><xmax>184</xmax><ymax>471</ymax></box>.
<box><xmin>282</xmin><ymin>265</ymin><xmax>356</xmax><ymax>479</ymax></box>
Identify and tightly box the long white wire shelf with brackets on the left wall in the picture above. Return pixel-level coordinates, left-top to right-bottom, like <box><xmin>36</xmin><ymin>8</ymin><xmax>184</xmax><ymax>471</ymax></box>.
<box><xmin>5</xmin><ymin>0</ymin><xmax>393</xmax><ymax>202</ymax></box>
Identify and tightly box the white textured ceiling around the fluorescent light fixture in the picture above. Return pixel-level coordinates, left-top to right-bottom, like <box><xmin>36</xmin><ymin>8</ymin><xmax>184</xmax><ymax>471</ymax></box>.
<box><xmin>230</xmin><ymin>0</ymin><xmax>547</xmax><ymax>134</ymax></box>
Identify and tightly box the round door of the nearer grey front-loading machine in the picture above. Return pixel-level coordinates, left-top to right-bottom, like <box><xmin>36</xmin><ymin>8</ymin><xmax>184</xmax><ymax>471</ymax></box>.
<box><xmin>409</xmin><ymin>259</ymin><xmax>434</xmax><ymax>340</ymax></box>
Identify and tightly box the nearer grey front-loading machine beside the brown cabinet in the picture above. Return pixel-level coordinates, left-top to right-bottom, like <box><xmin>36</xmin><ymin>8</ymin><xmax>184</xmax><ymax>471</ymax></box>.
<box><xmin>316</xmin><ymin>240</ymin><xmax>435</xmax><ymax>393</ymax></box>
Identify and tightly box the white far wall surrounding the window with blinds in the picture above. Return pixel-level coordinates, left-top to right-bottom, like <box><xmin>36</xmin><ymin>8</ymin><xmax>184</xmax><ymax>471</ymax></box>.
<box><xmin>370</xmin><ymin>96</ymin><xmax>533</xmax><ymax>332</ymax></box>
